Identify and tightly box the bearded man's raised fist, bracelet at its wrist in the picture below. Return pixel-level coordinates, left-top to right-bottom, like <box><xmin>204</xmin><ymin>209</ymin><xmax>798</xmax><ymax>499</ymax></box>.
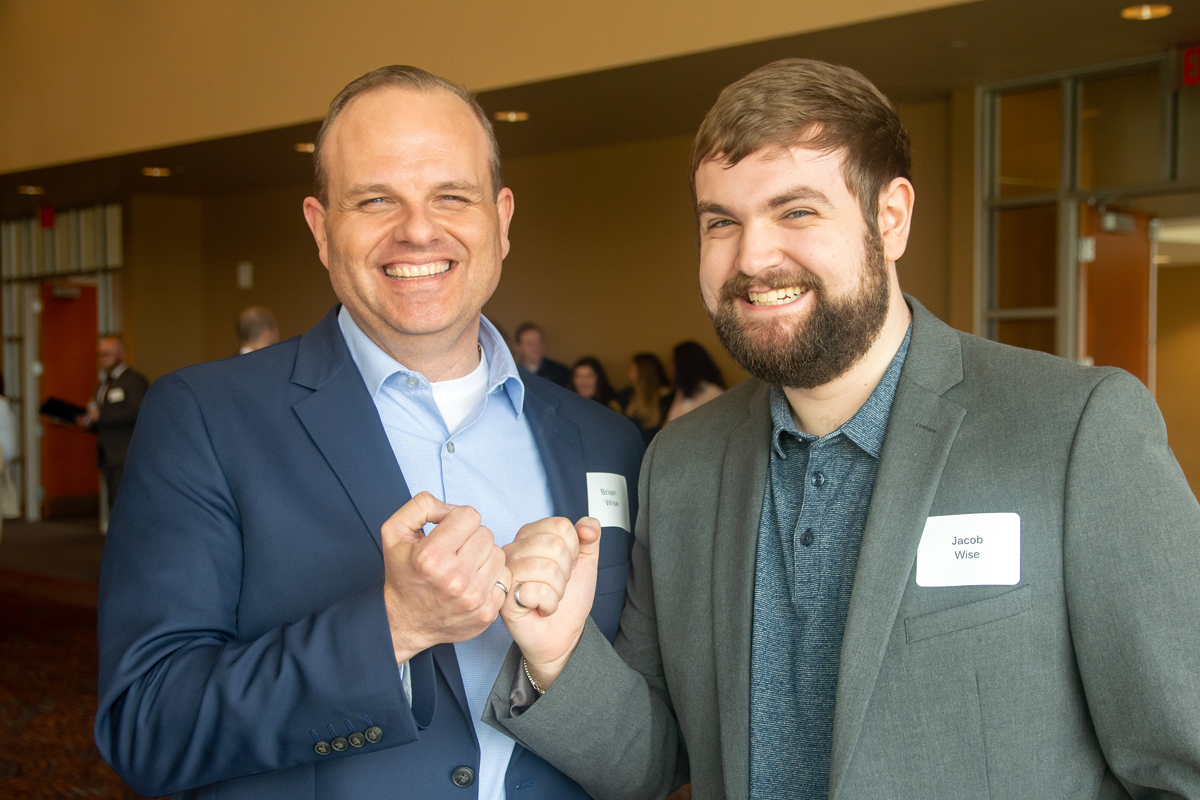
<box><xmin>500</xmin><ymin>517</ymin><xmax>600</xmax><ymax>690</ymax></box>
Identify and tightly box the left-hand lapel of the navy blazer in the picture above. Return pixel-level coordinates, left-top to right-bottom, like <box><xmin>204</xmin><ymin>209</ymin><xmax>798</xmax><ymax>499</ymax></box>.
<box><xmin>292</xmin><ymin>306</ymin><xmax>412</xmax><ymax>554</ymax></box>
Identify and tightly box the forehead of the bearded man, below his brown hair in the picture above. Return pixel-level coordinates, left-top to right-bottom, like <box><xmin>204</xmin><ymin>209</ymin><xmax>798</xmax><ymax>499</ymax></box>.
<box><xmin>696</xmin><ymin>145</ymin><xmax>854</xmax><ymax>207</ymax></box>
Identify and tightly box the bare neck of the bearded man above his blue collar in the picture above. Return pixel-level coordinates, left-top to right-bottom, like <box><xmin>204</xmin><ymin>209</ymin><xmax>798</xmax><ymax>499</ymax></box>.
<box><xmin>784</xmin><ymin>282</ymin><xmax>912</xmax><ymax>437</ymax></box>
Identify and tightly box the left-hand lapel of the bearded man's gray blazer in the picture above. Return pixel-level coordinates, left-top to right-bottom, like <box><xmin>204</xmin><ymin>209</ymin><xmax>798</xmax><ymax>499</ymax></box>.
<box><xmin>712</xmin><ymin>385</ymin><xmax>772</xmax><ymax>798</ymax></box>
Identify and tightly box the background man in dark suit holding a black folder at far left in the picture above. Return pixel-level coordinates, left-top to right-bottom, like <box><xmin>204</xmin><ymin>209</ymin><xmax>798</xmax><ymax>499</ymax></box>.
<box><xmin>76</xmin><ymin>335</ymin><xmax>150</xmax><ymax>510</ymax></box>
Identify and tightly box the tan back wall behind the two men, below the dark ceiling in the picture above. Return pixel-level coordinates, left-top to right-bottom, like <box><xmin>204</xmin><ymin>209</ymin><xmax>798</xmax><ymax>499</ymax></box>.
<box><xmin>126</xmin><ymin>102</ymin><xmax>950</xmax><ymax>386</ymax></box>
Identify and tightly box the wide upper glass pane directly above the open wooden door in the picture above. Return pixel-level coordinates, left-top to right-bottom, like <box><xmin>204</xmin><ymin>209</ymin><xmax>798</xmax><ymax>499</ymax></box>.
<box><xmin>1079</xmin><ymin>70</ymin><xmax>1164</xmax><ymax>188</ymax></box>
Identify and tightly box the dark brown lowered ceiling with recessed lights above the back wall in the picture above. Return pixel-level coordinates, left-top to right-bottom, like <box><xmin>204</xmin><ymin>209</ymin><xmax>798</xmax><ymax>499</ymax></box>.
<box><xmin>0</xmin><ymin>0</ymin><xmax>1200</xmax><ymax>217</ymax></box>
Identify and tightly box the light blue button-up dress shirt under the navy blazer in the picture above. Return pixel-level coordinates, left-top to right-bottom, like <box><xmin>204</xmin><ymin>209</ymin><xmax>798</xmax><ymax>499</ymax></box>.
<box><xmin>337</xmin><ymin>306</ymin><xmax>553</xmax><ymax>800</ymax></box>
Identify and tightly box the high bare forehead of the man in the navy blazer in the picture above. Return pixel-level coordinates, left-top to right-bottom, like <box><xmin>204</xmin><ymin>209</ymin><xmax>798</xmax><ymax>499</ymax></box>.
<box><xmin>322</xmin><ymin>86</ymin><xmax>490</xmax><ymax>184</ymax></box>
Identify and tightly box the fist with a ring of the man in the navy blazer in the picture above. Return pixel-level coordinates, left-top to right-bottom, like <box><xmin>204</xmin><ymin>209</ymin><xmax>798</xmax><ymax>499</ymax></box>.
<box><xmin>380</xmin><ymin>492</ymin><xmax>512</xmax><ymax>664</ymax></box>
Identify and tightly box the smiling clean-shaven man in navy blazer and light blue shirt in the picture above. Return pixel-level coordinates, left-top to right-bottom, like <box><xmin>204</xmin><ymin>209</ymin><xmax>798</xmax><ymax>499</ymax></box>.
<box><xmin>96</xmin><ymin>67</ymin><xmax>641</xmax><ymax>800</ymax></box>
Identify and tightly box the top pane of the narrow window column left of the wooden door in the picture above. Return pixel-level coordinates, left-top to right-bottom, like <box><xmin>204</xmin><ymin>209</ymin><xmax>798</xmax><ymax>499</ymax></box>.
<box><xmin>997</xmin><ymin>86</ymin><xmax>1062</xmax><ymax>197</ymax></box>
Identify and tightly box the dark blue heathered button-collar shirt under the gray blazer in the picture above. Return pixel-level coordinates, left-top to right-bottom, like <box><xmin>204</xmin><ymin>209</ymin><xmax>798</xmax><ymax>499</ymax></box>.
<box><xmin>750</xmin><ymin>325</ymin><xmax>912</xmax><ymax>800</ymax></box>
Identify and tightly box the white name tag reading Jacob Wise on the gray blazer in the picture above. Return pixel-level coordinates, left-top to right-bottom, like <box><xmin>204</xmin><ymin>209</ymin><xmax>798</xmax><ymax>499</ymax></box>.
<box><xmin>917</xmin><ymin>513</ymin><xmax>1021</xmax><ymax>587</ymax></box>
